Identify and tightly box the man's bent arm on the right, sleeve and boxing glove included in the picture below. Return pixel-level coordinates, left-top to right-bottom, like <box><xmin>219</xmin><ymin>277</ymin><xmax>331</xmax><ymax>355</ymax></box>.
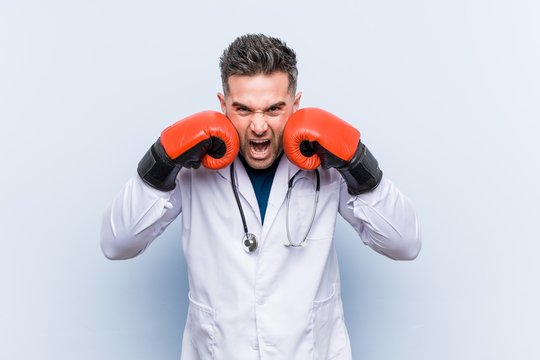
<box><xmin>283</xmin><ymin>108</ymin><xmax>421</xmax><ymax>260</ymax></box>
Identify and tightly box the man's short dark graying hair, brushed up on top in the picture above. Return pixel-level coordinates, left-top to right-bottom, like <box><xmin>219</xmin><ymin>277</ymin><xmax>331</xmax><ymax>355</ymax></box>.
<box><xmin>219</xmin><ymin>34</ymin><xmax>298</xmax><ymax>95</ymax></box>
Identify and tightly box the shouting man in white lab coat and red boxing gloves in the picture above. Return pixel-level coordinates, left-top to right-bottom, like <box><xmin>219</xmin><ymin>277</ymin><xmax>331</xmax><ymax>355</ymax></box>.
<box><xmin>101</xmin><ymin>35</ymin><xmax>420</xmax><ymax>360</ymax></box>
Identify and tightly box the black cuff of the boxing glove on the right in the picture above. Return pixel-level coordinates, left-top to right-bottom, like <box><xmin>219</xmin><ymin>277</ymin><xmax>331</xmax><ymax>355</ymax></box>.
<box><xmin>337</xmin><ymin>141</ymin><xmax>382</xmax><ymax>195</ymax></box>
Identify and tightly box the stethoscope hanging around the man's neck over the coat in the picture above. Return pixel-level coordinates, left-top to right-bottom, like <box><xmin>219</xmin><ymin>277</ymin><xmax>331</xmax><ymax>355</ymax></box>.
<box><xmin>231</xmin><ymin>162</ymin><xmax>321</xmax><ymax>254</ymax></box>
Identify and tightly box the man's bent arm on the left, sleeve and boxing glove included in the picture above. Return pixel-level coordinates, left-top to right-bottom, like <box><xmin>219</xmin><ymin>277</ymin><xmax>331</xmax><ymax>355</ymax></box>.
<box><xmin>101</xmin><ymin>111</ymin><xmax>239</xmax><ymax>259</ymax></box>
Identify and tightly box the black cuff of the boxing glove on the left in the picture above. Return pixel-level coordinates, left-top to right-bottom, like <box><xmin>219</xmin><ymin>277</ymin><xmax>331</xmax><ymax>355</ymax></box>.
<box><xmin>137</xmin><ymin>139</ymin><xmax>181</xmax><ymax>191</ymax></box>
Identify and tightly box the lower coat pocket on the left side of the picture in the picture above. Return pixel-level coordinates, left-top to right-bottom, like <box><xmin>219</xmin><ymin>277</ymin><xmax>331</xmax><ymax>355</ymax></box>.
<box><xmin>187</xmin><ymin>294</ymin><xmax>216</xmax><ymax>360</ymax></box>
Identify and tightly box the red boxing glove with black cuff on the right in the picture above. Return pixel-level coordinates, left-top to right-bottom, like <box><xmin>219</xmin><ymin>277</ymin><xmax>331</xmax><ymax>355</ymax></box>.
<box><xmin>283</xmin><ymin>108</ymin><xmax>382</xmax><ymax>195</ymax></box>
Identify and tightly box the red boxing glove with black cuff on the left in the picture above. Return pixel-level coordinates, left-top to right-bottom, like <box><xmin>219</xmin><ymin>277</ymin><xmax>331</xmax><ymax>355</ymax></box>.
<box><xmin>137</xmin><ymin>111</ymin><xmax>240</xmax><ymax>191</ymax></box>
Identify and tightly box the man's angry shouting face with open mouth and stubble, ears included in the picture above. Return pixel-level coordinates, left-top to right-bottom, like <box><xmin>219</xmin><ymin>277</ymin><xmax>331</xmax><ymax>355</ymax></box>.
<box><xmin>218</xmin><ymin>72</ymin><xmax>301</xmax><ymax>169</ymax></box>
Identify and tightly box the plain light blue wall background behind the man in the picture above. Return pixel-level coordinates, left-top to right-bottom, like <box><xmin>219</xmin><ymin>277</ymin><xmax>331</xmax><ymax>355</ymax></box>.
<box><xmin>0</xmin><ymin>0</ymin><xmax>540</xmax><ymax>360</ymax></box>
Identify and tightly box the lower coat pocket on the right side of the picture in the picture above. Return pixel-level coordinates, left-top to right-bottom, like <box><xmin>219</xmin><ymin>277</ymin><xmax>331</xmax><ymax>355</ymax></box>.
<box><xmin>313</xmin><ymin>286</ymin><xmax>347</xmax><ymax>360</ymax></box>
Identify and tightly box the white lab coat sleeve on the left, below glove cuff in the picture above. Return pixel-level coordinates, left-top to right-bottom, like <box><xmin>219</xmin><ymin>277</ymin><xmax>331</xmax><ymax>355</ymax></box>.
<box><xmin>101</xmin><ymin>175</ymin><xmax>181</xmax><ymax>260</ymax></box>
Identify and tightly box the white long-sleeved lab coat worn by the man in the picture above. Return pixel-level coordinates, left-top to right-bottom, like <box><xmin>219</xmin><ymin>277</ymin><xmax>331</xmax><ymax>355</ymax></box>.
<box><xmin>101</xmin><ymin>156</ymin><xmax>420</xmax><ymax>360</ymax></box>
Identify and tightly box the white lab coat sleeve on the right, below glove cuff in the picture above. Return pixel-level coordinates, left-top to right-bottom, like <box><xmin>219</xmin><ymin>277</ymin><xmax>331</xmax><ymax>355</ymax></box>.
<box><xmin>339</xmin><ymin>177</ymin><xmax>421</xmax><ymax>260</ymax></box>
